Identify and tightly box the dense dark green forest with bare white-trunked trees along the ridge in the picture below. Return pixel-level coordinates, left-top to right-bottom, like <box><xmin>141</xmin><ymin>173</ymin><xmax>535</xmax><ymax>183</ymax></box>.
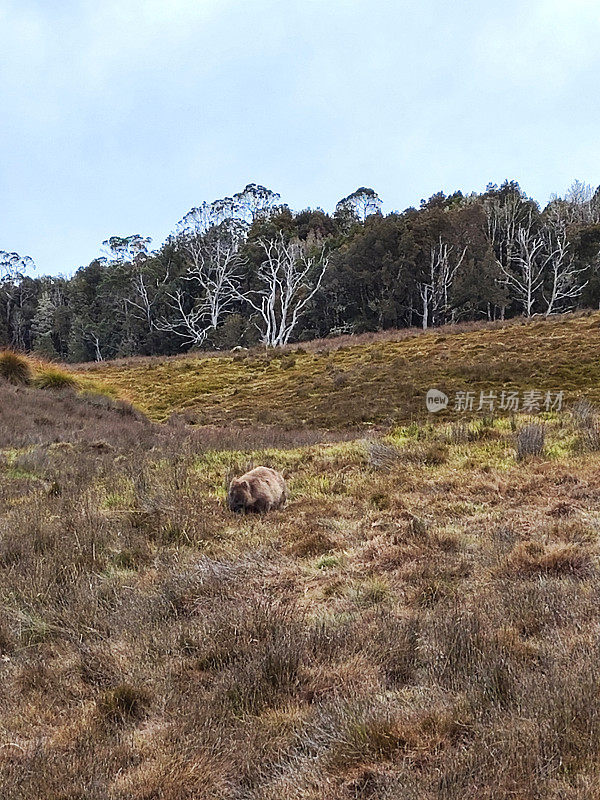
<box><xmin>0</xmin><ymin>181</ymin><xmax>600</xmax><ymax>362</ymax></box>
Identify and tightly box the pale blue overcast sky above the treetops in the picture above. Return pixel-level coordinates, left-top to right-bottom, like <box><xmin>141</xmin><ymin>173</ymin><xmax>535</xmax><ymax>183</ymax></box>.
<box><xmin>0</xmin><ymin>0</ymin><xmax>600</xmax><ymax>274</ymax></box>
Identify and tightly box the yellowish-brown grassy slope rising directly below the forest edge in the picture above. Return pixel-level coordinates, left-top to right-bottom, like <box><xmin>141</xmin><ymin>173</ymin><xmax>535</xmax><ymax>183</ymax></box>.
<box><xmin>79</xmin><ymin>313</ymin><xmax>600</xmax><ymax>428</ymax></box>
